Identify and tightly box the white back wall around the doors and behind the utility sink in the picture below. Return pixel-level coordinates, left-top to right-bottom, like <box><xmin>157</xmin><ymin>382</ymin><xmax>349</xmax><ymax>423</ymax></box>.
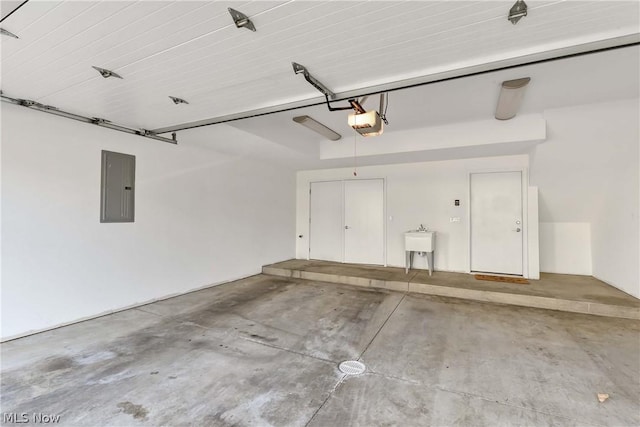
<box><xmin>296</xmin><ymin>155</ymin><xmax>528</xmax><ymax>271</ymax></box>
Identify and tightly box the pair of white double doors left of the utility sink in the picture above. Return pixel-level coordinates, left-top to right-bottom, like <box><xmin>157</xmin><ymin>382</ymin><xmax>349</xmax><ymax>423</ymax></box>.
<box><xmin>309</xmin><ymin>179</ymin><xmax>384</xmax><ymax>265</ymax></box>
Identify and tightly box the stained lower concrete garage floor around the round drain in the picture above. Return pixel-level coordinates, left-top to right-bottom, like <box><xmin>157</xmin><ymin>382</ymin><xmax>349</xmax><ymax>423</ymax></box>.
<box><xmin>1</xmin><ymin>275</ymin><xmax>640</xmax><ymax>426</ymax></box>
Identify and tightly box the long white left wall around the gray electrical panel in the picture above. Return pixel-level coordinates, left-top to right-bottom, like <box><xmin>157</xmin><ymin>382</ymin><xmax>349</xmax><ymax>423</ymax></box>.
<box><xmin>1</xmin><ymin>103</ymin><xmax>295</xmax><ymax>339</ymax></box>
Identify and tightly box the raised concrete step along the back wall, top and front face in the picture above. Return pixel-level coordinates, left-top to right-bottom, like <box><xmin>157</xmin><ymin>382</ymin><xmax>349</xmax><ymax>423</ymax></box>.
<box><xmin>262</xmin><ymin>260</ymin><xmax>640</xmax><ymax>319</ymax></box>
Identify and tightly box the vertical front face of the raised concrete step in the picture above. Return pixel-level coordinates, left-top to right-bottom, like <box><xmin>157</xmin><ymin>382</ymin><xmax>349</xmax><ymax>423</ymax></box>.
<box><xmin>262</xmin><ymin>266</ymin><xmax>640</xmax><ymax>320</ymax></box>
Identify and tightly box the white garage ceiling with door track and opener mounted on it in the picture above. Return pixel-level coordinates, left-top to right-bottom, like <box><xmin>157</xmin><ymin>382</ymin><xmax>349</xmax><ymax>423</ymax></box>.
<box><xmin>0</xmin><ymin>0</ymin><xmax>640</xmax><ymax>169</ymax></box>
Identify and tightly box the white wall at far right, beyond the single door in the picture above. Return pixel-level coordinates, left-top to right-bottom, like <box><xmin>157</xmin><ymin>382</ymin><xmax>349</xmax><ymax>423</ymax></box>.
<box><xmin>530</xmin><ymin>98</ymin><xmax>640</xmax><ymax>297</ymax></box>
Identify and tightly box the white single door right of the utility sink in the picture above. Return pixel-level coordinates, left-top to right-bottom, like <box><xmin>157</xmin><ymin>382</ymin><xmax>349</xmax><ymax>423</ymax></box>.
<box><xmin>470</xmin><ymin>172</ymin><xmax>524</xmax><ymax>275</ymax></box>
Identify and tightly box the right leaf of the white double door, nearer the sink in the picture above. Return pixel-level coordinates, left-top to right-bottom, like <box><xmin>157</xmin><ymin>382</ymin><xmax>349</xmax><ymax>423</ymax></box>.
<box><xmin>344</xmin><ymin>179</ymin><xmax>384</xmax><ymax>265</ymax></box>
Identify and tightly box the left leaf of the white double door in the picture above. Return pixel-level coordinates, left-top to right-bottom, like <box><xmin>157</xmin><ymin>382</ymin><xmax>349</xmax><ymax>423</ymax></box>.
<box><xmin>309</xmin><ymin>181</ymin><xmax>344</xmax><ymax>262</ymax></box>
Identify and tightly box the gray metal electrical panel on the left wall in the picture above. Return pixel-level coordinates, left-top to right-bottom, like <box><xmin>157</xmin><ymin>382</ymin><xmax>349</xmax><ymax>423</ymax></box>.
<box><xmin>100</xmin><ymin>150</ymin><xmax>136</xmax><ymax>222</ymax></box>
